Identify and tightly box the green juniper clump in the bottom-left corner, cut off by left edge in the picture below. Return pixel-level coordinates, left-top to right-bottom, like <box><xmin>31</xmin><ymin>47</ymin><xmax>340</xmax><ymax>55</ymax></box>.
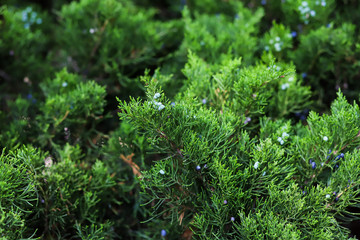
<box><xmin>0</xmin><ymin>147</ymin><xmax>43</xmax><ymax>239</ymax></box>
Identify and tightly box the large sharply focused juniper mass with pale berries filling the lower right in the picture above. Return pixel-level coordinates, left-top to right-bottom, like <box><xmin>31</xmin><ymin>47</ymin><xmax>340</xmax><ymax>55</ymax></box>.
<box><xmin>120</xmin><ymin>78</ymin><xmax>359</xmax><ymax>239</ymax></box>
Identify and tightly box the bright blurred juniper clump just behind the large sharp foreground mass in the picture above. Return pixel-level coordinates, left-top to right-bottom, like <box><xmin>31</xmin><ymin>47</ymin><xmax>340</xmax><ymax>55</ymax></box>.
<box><xmin>184</xmin><ymin>53</ymin><xmax>310</xmax><ymax>122</ymax></box>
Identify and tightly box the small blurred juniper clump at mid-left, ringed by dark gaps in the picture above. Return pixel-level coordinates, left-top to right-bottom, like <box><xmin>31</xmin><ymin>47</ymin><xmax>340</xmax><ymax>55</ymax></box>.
<box><xmin>36</xmin><ymin>70</ymin><xmax>106</xmax><ymax>149</ymax></box>
